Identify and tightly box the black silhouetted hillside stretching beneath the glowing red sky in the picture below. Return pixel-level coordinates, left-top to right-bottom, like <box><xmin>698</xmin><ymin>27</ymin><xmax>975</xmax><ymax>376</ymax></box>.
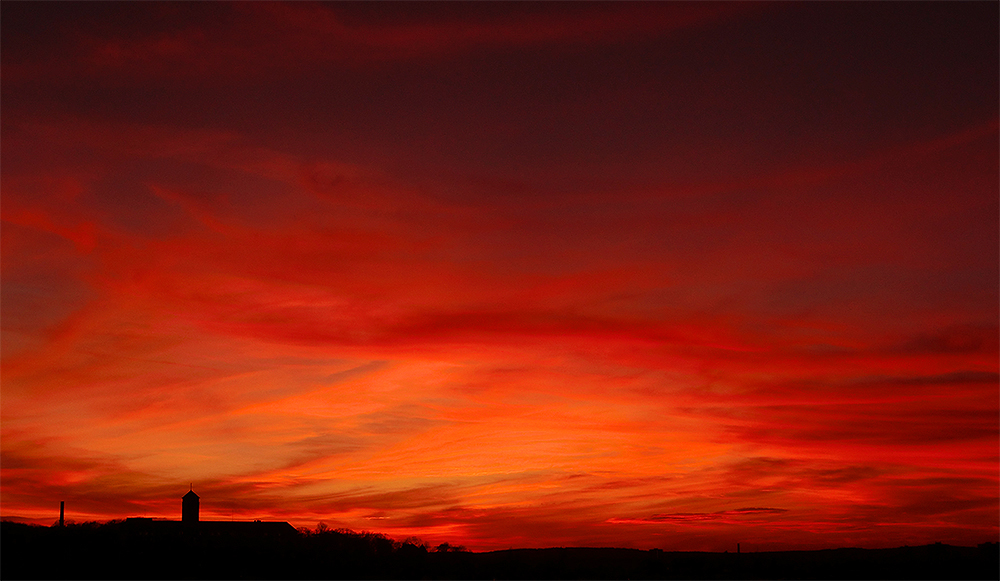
<box><xmin>0</xmin><ymin>521</ymin><xmax>1000</xmax><ymax>579</ymax></box>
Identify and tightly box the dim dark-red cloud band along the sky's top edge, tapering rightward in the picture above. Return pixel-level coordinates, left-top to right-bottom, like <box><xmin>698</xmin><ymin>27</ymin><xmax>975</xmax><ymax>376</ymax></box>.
<box><xmin>4</xmin><ymin>3</ymin><xmax>755</xmax><ymax>85</ymax></box>
